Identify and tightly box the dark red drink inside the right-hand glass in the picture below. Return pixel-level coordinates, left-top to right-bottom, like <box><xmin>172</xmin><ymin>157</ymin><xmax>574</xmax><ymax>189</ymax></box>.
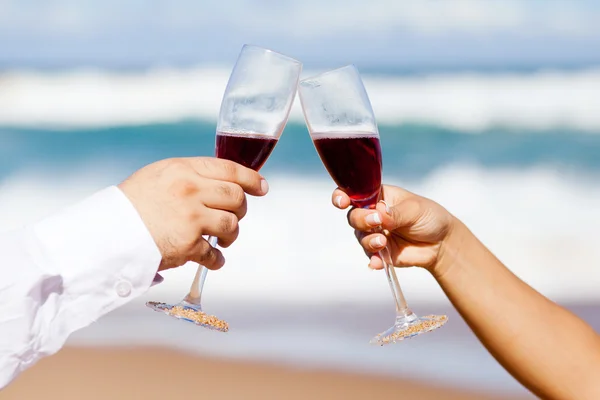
<box><xmin>313</xmin><ymin>133</ymin><xmax>381</xmax><ymax>207</ymax></box>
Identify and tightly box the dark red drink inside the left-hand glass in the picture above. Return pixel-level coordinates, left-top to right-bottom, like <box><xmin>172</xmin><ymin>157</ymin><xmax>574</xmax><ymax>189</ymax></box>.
<box><xmin>215</xmin><ymin>132</ymin><xmax>277</xmax><ymax>171</ymax></box>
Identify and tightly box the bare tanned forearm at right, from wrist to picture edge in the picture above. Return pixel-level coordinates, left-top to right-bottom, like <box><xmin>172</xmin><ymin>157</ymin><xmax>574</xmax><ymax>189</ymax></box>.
<box><xmin>436</xmin><ymin>222</ymin><xmax>600</xmax><ymax>400</ymax></box>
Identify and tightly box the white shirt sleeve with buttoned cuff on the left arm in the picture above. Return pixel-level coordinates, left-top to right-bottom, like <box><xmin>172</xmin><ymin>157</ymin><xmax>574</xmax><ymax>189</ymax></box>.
<box><xmin>0</xmin><ymin>186</ymin><xmax>161</xmax><ymax>389</ymax></box>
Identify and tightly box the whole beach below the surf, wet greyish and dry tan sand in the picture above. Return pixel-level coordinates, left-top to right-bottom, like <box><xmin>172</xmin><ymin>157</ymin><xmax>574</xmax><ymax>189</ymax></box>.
<box><xmin>5</xmin><ymin>301</ymin><xmax>600</xmax><ymax>400</ymax></box>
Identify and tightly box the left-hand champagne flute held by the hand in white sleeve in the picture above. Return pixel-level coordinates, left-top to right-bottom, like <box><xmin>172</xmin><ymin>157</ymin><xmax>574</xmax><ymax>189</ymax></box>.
<box><xmin>146</xmin><ymin>45</ymin><xmax>302</xmax><ymax>331</ymax></box>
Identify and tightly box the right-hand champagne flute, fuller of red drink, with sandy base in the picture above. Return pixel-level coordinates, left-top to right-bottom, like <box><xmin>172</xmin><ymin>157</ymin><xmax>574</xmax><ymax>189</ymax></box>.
<box><xmin>298</xmin><ymin>65</ymin><xmax>447</xmax><ymax>345</ymax></box>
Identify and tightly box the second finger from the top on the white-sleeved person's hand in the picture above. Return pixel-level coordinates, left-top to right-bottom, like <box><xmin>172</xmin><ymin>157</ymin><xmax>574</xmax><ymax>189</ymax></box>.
<box><xmin>202</xmin><ymin>180</ymin><xmax>248</xmax><ymax>220</ymax></box>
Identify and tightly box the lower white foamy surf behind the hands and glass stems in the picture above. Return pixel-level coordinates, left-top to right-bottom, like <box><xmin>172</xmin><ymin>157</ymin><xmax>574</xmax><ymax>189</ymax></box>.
<box><xmin>0</xmin><ymin>165</ymin><xmax>600</xmax><ymax>304</ymax></box>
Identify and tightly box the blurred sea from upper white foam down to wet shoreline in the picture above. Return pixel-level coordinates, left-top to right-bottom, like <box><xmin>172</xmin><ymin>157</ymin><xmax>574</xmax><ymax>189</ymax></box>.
<box><xmin>0</xmin><ymin>67</ymin><xmax>600</xmax><ymax>392</ymax></box>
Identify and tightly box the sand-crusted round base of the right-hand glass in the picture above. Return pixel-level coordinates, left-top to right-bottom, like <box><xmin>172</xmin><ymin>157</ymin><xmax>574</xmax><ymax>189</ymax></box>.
<box><xmin>370</xmin><ymin>313</ymin><xmax>448</xmax><ymax>346</ymax></box>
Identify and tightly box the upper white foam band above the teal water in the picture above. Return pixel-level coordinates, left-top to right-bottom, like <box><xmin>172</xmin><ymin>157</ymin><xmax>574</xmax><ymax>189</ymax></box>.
<box><xmin>0</xmin><ymin>67</ymin><xmax>600</xmax><ymax>133</ymax></box>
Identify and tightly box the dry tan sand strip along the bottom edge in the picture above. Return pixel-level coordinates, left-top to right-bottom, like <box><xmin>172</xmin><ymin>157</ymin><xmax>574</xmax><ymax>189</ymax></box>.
<box><xmin>0</xmin><ymin>347</ymin><xmax>522</xmax><ymax>400</ymax></box>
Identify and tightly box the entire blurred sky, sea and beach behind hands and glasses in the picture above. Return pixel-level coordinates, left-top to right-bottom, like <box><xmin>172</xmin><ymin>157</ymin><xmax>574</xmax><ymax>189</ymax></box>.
<box><xmin>0</xmin><ymin>0</ymin><xmax>600</xmax><ymax>399</ymax></box>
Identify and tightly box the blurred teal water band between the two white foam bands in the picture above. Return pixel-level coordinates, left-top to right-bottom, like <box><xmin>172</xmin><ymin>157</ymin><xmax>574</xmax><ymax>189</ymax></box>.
<box><xmin>0</xmin><ymin>121</ymin><xmax>600</xmax><ymax>180</ymax></box>
